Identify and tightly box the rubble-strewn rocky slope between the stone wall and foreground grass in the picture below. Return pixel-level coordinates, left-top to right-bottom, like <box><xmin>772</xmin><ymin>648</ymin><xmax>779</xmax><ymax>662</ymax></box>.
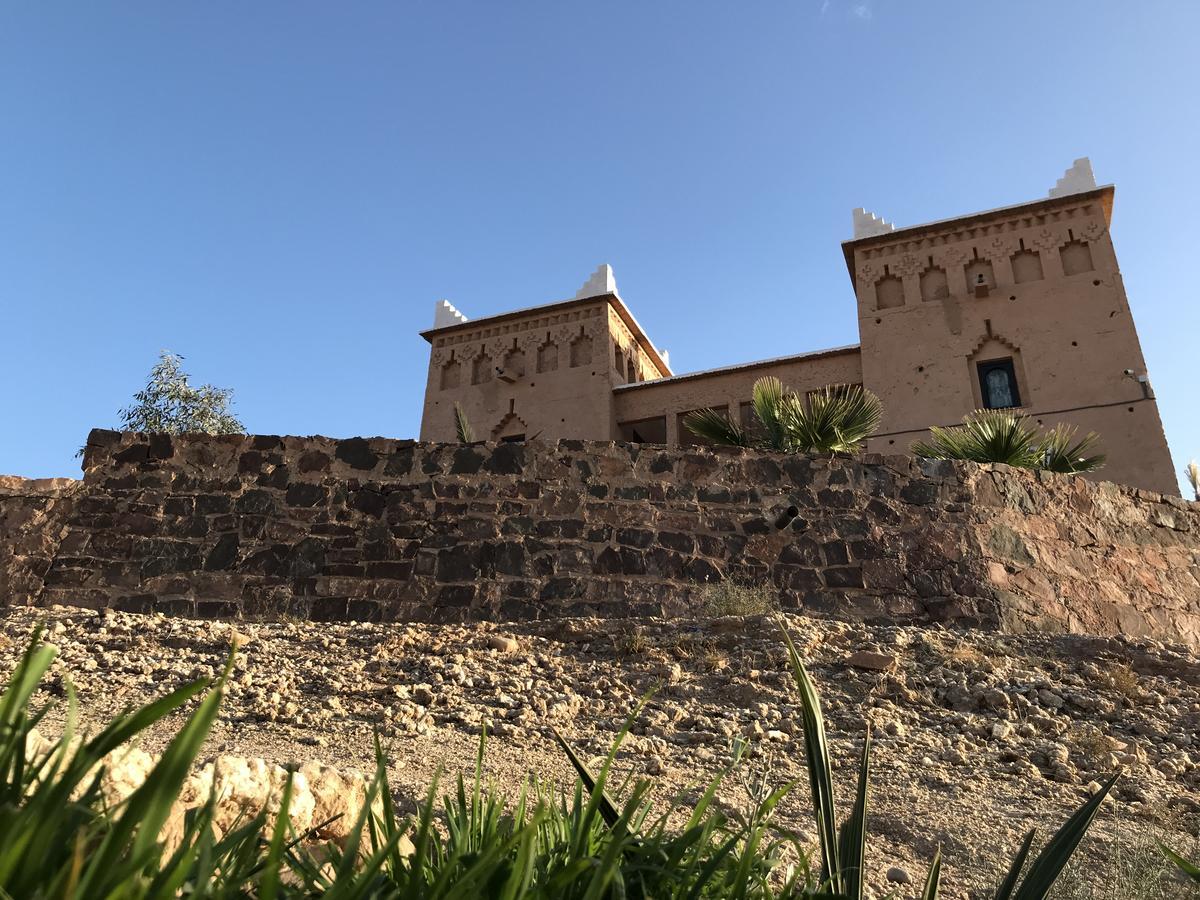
<box><xmin>0</xmin><ymin>607</ymin><xmax>1200</xmax><ymax>898</ymax></box>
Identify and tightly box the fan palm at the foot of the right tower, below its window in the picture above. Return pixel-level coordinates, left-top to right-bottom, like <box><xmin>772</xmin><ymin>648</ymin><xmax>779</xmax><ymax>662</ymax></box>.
<box><xmin>911</xmin><ymin>409</ymin><xmax>1105</xmax><ymax>474</ymax></box>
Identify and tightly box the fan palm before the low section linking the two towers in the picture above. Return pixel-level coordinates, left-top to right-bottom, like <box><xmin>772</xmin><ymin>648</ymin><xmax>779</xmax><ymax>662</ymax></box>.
<box><xmin>684</xmin><ymin>376</ymin><xmax>883</xmax><ymax>454</ymax></box>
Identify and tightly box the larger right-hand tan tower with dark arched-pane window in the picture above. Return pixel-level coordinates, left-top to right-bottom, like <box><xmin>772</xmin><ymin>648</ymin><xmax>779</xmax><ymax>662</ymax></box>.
<box><xmin>842</xmin><ymin>158</ymin><xmax>1177</xmax><ymax>493</ymax></box>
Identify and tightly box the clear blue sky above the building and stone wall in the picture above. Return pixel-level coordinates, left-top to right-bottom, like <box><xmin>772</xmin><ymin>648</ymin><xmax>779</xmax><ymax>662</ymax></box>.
<box><xmin>0</xmin><ymin>0</ymin><xmax>1200</xmax><ymax>494</ymax></box>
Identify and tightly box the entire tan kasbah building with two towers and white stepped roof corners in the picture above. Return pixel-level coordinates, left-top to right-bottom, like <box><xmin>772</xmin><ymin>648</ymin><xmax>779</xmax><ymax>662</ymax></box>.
<box><xmin>421</xmin><ymin>158</ymin><xmax>1178</xmax><ymax>494</ymax></box>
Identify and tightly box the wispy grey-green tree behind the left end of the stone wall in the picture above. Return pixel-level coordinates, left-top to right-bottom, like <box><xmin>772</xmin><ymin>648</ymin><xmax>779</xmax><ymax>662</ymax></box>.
<box><xmin>120</xmin><ymin>350</ymin><xmax>246</xmax><ymax>434</ymax></box>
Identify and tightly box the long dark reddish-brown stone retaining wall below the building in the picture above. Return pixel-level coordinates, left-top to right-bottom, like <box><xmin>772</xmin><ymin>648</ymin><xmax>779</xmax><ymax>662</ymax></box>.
<box><xmin>0</xmin><ymin>431</ymin><xmax>1200</xmax><ymax>646</ymax></box>
